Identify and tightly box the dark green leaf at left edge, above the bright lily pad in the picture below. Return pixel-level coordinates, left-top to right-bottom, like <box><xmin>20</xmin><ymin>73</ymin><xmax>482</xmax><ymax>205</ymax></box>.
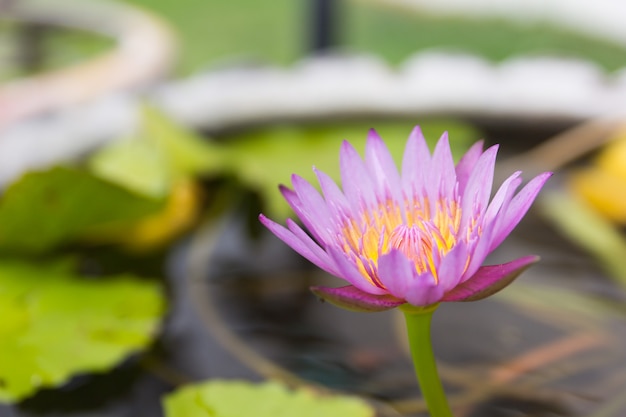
<box><xmin>0</xmin><ymin>167</ymin><xmax>163</xmax><ymax>252</ymax></box>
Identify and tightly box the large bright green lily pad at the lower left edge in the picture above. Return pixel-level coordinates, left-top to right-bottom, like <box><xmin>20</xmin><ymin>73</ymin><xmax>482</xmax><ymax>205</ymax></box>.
<box><xmin>0</xmin><ymin>261</ymin><xmax>165</xmax><ymax>402</ymax></box>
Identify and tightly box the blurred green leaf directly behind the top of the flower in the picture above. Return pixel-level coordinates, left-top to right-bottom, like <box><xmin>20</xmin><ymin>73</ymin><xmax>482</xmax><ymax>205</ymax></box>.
<box><xmin>222</xmin><ymin>120</ymin><xmax>479</xmax><ymax>217</ymax></box>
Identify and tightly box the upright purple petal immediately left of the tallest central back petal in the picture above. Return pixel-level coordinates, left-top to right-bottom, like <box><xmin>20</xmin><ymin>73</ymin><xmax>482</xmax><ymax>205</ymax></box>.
<box><xmin>365</xmin><ymin>129</ymin><xmax>400</xmax><ymax>198</ymax></box>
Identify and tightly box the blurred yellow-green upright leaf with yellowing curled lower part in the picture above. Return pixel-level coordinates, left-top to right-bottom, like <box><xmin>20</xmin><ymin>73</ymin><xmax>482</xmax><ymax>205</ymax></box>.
<box><xmin>88</xmin><ymin>106</ymin><xmax>213</xmax><ymax>251</ymax></box>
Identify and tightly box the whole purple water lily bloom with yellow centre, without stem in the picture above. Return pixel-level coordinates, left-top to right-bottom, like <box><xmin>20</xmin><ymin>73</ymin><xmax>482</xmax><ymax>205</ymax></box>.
<box><xmin>259</xmin><ymin>127</ymin><xmax>551</xmax><ymax>311</ymax></box>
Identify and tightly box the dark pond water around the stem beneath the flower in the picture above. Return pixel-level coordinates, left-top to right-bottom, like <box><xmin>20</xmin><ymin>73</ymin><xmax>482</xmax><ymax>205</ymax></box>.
<box><xmin>0</xmin><ymin>118</ymin><xmax>626</xmax><ymax>417</ymax></box>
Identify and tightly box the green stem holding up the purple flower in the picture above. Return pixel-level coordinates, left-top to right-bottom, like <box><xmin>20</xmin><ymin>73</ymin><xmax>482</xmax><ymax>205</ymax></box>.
<box><xmin>400</xmin><ymin>304</ymin><xmax>452</xmax><ymax>417</ymax></box>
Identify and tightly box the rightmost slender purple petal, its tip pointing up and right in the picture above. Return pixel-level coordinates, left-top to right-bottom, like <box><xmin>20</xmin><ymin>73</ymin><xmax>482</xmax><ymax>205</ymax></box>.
<box><xmin>490</xmin><ymin>172</ymin><xmax>552</xmax><ymax>251</ymax></box>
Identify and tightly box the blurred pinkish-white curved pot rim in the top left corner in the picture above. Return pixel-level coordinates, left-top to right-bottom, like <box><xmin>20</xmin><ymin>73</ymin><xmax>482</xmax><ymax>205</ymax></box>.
<box><xmin>0</xmin><ymin>0</ymin><xmax>175</xmax><ymax>130</ymax></box>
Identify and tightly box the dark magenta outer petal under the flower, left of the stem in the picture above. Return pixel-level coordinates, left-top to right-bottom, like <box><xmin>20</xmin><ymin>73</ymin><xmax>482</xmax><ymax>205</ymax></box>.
<box><xmin>311</xmin><ymin>285</ymin><xmax>404</xmax><ymax>313</ymax></box>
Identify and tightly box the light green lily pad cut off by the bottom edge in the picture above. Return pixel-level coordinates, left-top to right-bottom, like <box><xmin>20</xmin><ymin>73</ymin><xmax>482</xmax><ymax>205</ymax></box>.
<box><xmin>164</xmin><ymin>381</ymin><xmax>374</xmax><ymax>417</ymax></box>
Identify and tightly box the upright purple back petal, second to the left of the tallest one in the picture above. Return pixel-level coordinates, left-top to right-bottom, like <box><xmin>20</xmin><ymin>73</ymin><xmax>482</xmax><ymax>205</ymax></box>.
<box><xmin>339</xmin><ymin>141</ymin><xmax>376</xmax><ymax>211</ymax></box>
